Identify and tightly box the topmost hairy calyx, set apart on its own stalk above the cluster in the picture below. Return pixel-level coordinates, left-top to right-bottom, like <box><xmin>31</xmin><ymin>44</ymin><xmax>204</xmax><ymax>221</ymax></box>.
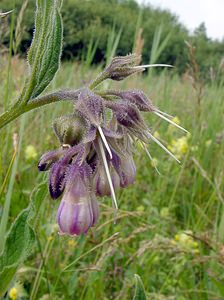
<box><xmin>104</xmin><ymin>54</ymin><xmax>144</xmax><ymax>81</ymax></box>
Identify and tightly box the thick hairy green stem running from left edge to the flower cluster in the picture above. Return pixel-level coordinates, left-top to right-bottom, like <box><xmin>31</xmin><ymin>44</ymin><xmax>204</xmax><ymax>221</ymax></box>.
<box><xmin>0</xmin><ymin>90</ymin><xmax>80</xmax><ymax>128</ymax></box>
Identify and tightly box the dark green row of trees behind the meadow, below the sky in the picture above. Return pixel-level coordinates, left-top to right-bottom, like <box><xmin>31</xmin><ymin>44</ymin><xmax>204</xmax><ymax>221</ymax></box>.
<box><xmin>0</xmin><ymin>0</ymin><xmax>224</xmax><ymax>72</ymax></box>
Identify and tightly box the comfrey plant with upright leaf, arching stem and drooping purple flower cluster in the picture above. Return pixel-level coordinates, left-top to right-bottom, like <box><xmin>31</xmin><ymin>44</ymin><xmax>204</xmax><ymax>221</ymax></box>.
<box><xmin>0</xmin><ymin>0</ymin><xmax>185</xmax><ymax>239</ymax></box>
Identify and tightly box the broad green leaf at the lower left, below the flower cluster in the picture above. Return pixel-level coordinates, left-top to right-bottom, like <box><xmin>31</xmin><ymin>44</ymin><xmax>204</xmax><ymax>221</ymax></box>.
<box><xmin>0</xmin><ymin>183</ymin><xmax>46</xmax><ymax>297</ymax></box>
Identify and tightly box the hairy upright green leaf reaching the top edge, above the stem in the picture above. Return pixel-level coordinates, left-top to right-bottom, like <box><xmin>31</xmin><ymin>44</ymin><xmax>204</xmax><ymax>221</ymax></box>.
<box><xmin>25</xmin><ymin>0</ymin><xmax>63</xmax><ymax>101</ymax></box>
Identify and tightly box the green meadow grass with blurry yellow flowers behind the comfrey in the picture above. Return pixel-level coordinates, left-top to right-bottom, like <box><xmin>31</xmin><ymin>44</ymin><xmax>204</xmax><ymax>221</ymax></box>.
<box><xmin>0</xmin><ymin>57</ymin><xmax>224</xmax><ymax>300</ymax></box>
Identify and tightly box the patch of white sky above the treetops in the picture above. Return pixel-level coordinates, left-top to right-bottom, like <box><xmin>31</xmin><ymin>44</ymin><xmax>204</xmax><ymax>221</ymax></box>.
<box><xmin>137</xmin><ymin>0</ymin><xmax>224</xmax><ymax>39</ymax></box>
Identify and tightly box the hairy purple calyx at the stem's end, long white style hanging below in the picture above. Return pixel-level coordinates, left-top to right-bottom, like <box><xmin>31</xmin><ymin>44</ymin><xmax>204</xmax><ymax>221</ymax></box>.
<box><xmin>76</xmin><ymin>89</ymin><xmax>103</xmax><ymax>127</ymax></box>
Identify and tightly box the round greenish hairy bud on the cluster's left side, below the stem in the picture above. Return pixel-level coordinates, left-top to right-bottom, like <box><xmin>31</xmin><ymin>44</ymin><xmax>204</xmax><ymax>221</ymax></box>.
<box><xmin>53</xmin><ymin>114</ymin><xmax>87</xmax><ymax>146</ymax></box>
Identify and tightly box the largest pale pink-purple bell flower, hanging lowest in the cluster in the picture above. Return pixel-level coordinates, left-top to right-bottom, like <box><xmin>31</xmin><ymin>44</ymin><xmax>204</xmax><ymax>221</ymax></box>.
<box><xmin>58</xmin><ymin>166</ymin><xmax>94</xmax><ymax>235</ymax></box>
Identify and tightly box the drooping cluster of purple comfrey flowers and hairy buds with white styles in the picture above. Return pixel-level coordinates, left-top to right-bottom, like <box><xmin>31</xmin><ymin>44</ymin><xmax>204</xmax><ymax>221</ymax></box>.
<box><xmin>38</xmin><ymin>55</ymin><xmax>186</xmax><ymax>235</ymax></box>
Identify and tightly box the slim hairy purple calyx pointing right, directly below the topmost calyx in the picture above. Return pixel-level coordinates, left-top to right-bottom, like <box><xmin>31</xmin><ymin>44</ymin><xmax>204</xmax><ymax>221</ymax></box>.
<box><xmin>109</xmin><ymin>90</ymin><xmax>155</xmax><ymax>112</ymax></box>
